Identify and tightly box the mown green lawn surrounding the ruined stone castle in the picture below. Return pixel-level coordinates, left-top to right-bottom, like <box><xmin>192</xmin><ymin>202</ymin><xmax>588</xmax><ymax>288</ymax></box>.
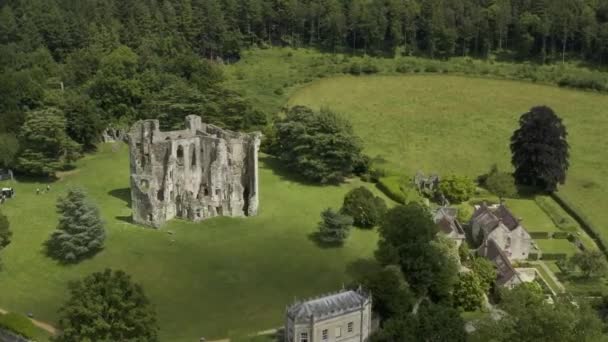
<box><xmin>0</xmin><ymin>145</ymin><xmax>378</xmax><ymax>341</ymax></box>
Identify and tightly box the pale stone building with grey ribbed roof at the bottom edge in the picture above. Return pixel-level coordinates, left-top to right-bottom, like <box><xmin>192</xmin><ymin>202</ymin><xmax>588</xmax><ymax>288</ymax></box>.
<box><xmin>285</xmin><ymin>287</ymin><xmax>372</xmax><ymax>342</ymax></box>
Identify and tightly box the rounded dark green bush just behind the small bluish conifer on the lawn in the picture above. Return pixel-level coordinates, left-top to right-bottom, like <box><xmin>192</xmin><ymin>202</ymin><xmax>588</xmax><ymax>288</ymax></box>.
<box><xmin>340</xmin><ymin>186</ymin><xmax>386</xmax><ymax>228</ymax></box>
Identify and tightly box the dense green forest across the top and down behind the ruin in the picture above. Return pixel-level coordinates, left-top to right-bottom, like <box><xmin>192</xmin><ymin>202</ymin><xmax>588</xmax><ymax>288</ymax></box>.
<box><xmin>0</xmin><ymin>0</ymin><xmax>608</xmax><ymax>174</ymax></box>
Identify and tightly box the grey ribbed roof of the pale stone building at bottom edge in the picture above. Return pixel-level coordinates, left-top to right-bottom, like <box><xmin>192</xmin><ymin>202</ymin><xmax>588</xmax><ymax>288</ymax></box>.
<box><xmin>287</xmin><ymin>288</ymin><xmax>371</xmax><ymax>322</ymax></box>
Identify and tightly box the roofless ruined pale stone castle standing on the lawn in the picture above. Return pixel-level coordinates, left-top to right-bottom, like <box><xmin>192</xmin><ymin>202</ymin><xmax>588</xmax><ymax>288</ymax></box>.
<box><xmin>129</xmin><ymin>115</ymin><xmax>261</xmax><ymax>228</ymax></box>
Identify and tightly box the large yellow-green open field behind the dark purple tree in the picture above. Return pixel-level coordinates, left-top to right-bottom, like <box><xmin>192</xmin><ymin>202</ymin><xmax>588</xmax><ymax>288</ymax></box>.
<box><xmin>289</xmin><ymin>75</ymin><xmax>608</xmax><ymax>238</ymax></box>
